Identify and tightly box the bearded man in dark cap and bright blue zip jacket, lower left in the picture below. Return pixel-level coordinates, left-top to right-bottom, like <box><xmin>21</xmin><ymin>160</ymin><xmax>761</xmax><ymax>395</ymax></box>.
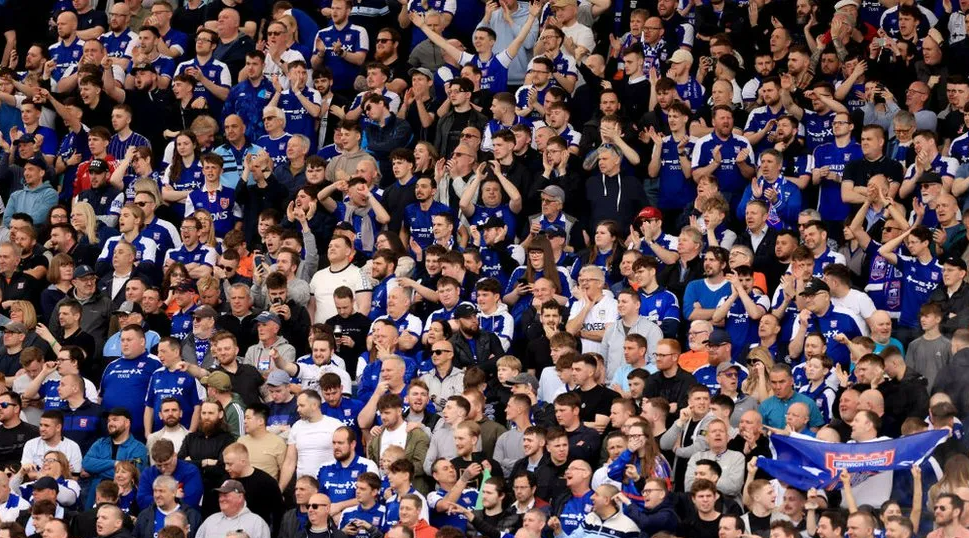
<box><xmin>81</xmin><ymin>407</ymin><xmax>148</xmax><ymax>506</ymax></box>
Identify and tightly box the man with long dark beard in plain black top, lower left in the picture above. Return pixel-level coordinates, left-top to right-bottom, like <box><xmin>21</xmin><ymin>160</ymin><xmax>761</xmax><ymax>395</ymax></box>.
<box><xmin>178</xmin><ymin>400</ymin><xmax>235</xmax><ymax>514</ymax></box>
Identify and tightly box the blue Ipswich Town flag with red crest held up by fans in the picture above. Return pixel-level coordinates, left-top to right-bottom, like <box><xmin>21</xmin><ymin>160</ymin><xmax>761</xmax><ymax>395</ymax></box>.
<box><xmin>757</xmin><ymin>430</ymin><xmax>949</xmax><ymax>491</ymax></box>
